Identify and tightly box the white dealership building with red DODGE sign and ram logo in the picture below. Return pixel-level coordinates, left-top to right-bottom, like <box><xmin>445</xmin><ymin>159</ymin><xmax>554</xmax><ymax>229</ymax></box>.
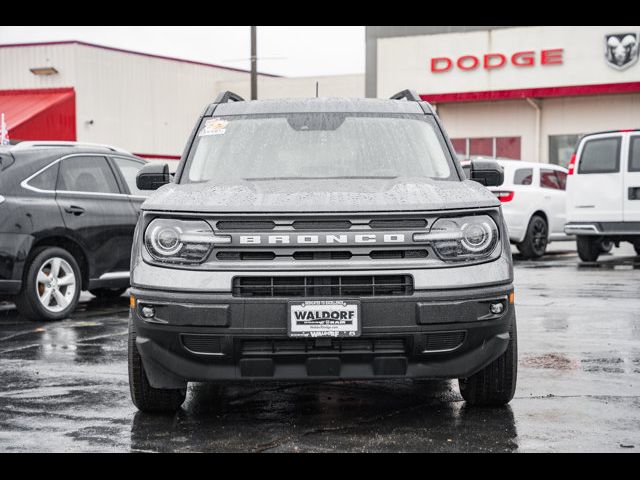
<box><xmin>366</xmin><ymin>26</ymin><xmax>640</xmax><ymax>165</ymax></box>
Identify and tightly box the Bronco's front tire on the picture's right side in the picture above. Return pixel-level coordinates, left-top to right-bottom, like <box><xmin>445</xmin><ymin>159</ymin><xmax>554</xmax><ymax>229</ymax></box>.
<box><xmin>458</xmin><ymin>318</ymin><xmax>518</xmax><ymax>407</ymax></box>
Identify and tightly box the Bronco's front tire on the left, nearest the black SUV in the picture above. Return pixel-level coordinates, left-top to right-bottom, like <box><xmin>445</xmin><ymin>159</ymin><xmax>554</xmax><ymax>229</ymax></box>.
<box><xmin>128</xmin><ymin>321</ymin><xmax>186</xmax><ymax>413</ymax></box>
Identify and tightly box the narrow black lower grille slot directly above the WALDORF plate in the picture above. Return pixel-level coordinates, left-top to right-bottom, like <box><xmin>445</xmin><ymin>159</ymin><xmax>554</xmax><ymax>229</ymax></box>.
<box><xmin>233</xmin><ymin>275</ymin><xmax>413</xmax><ymax>297</ymax></box>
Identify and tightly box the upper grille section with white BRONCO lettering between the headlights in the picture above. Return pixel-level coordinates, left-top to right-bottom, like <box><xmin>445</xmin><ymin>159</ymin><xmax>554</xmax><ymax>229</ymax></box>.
<box><xmin>204</xmin><ymin>213</ymin><xmax>438</xmax><ymax>270</ymax></box>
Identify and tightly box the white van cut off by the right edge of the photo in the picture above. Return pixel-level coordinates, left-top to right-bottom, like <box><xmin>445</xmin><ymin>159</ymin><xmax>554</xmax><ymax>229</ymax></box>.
<box><xmin>565</xmin><ymin>130</ymin><xmax>640</xmax><ymax>262</ymax></box>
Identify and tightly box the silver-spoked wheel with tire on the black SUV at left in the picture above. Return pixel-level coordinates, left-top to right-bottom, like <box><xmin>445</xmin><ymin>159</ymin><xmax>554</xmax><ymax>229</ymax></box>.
<box><xmin>16</xmin><ymin>247</ymin><xmax>82</xmax><ymax>320</ymax></box>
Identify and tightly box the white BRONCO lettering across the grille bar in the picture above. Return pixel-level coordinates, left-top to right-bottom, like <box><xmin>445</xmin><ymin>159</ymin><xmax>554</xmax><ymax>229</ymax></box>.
<box><xmin>238</xmin><ymin>233</ymin><xmax>406</xmax><ymax>246</ymax></box>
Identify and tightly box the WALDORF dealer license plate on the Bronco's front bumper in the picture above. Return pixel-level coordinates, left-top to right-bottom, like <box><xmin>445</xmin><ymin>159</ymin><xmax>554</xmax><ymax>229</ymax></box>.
<box><xmin>287</xmin><ymin>299</ymin><xmax>362</xmax><ymax>338</ymax></box>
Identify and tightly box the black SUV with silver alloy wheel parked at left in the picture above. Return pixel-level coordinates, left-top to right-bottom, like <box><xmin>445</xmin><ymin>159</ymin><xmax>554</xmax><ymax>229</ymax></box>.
<box><xmin>0</xmin><ymin>141</ymin><xmax>147</xmax><ymax>320</ymax></box>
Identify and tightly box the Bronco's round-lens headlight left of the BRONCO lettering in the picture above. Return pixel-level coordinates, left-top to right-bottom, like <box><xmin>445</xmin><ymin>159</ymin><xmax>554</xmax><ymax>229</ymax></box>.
<box><xmin>144</xmin><ymin>218</ymin><xmax>231</xmax><ymax>263</ymax></box>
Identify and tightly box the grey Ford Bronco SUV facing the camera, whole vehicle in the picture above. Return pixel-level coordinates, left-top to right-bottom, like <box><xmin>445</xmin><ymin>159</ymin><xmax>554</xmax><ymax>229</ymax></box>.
<box><xmin>129</xmin><ymin>91</ymin><xmax>517</xmax><ymax>411</ymax></box>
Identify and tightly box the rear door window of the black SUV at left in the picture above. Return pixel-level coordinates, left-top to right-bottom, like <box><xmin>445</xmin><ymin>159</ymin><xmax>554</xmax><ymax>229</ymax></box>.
<box><xmin>57</xmin><ymin>157</ymin><xmax>120</xmax><ymax>193</ymax></box>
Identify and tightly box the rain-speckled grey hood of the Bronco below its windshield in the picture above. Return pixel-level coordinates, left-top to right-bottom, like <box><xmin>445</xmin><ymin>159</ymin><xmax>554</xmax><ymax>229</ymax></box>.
<box><xmin>142</xmin><ymin>177</ymin><xmax>500</xmax><ymax>213</ymax></box>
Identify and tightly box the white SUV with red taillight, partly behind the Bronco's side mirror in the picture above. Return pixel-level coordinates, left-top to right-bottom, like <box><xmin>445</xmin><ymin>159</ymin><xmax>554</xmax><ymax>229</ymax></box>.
<box><xmin>463</xmin><ymin>157</ymin><xmax>569</xmax><ymax>258</ymax></box>
